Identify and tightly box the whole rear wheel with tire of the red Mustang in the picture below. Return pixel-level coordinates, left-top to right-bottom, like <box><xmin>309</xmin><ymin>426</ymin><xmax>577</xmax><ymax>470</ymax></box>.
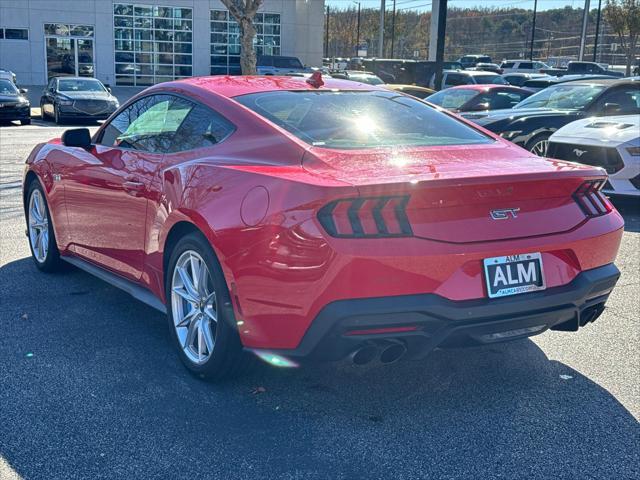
<box><xmin>165</xmin><ymin>233</ymin><xmax>248</xmax><ymax>380</ymax></box>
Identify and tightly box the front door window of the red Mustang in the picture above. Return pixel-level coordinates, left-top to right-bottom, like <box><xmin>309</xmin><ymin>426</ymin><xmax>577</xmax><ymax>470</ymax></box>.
<box><xmin>98</xmin><ymin>95</ymin><xmax>194</xmax><ymax>153</ymax></box>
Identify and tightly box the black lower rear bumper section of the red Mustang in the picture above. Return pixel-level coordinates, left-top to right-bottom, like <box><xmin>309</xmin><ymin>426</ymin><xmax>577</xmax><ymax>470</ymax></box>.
<box><xmin>258</xmin><ymin>264</ymin><xmax>620</xmax><ymax>361</ymax></box>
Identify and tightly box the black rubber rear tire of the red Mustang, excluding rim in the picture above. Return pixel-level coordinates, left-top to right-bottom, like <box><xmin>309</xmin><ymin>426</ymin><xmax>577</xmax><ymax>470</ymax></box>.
<box><xmin>165</xmin><ymin>232</ymin><xmax>251</xmax><ymax>381</ymax></box>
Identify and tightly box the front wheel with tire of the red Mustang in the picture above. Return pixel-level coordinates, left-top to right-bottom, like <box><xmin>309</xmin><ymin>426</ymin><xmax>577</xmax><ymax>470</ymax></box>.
<box><xmin>27</xmin><ymin>180</ymin><xmax>62</xmax><ymax>272</ymax></box>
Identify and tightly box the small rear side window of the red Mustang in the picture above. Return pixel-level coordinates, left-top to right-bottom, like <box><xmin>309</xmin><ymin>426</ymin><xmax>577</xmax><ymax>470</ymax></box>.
<box><xmin>167</xmin><ymin>105</ymin><xmax>235</xmax><ymax>152</ymax></box>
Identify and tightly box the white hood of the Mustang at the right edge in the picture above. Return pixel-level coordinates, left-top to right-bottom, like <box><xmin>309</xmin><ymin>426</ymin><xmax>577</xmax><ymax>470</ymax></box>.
<box><xmin>551</xmin><ymin>115</ymin><xmax>640</xmax><ymax>145</ymax></box>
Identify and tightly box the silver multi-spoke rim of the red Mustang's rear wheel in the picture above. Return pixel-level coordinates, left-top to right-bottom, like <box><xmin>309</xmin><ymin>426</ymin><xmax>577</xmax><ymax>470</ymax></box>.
<box><xmin>171</xmin><ymin>250</ymin><xmax>218</xmax><ymax>365</ymax></box>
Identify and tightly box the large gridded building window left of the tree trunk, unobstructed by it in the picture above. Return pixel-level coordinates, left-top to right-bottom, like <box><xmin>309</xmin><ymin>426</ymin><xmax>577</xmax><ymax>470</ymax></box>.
<box><xmin>113</xmin><ymin>3</ymin><xmax>193</xmax><ymax>86</ymax></box>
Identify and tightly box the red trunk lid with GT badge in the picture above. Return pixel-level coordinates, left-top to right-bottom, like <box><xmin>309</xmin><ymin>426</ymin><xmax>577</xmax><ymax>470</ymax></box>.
<box><xmin>303</xmin><ymin>142</ymin><xmax>606</xmax><ymax>243</ymax></box>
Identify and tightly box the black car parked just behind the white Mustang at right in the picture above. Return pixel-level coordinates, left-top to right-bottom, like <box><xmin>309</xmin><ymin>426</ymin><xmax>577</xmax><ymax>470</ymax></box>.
<box><xmin>463</xmin><ymin>78</ymin><xmax>640</xmax><ymax>156</ymax></box>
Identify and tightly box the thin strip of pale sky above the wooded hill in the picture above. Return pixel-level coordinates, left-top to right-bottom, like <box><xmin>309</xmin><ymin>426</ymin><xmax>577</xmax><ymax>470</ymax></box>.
<box><xmin>325</xmin><ymin>0</ymin><xmax>592</xmax><ymax>11</ymax></box>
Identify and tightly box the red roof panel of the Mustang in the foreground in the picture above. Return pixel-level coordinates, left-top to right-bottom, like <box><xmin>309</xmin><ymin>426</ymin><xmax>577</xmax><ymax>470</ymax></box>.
<box><xmin>172</xmin><ymin>75</ymin><xmax>384</xmax><ymax>98</ymax></box>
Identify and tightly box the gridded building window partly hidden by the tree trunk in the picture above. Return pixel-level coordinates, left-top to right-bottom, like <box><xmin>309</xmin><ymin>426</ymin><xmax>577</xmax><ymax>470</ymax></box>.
<box><xmin>210</xmin><ymin>10</ymin><xmax>280</xmax><ymax>75</ymax></box>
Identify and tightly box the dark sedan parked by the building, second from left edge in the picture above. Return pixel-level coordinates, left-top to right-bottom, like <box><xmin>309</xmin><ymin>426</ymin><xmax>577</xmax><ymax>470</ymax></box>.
<box><xmin>40</xmin><ymin>77</ymin><xmax>120</xmax><ymax>123</ymax></box>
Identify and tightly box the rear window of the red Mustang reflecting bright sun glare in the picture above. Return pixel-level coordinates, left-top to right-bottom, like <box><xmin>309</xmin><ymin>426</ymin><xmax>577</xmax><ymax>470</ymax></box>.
<box><xmin>234</xmin><ymin>90</ymin><xmax>493</xmax><ymax>149</ymax></box>
